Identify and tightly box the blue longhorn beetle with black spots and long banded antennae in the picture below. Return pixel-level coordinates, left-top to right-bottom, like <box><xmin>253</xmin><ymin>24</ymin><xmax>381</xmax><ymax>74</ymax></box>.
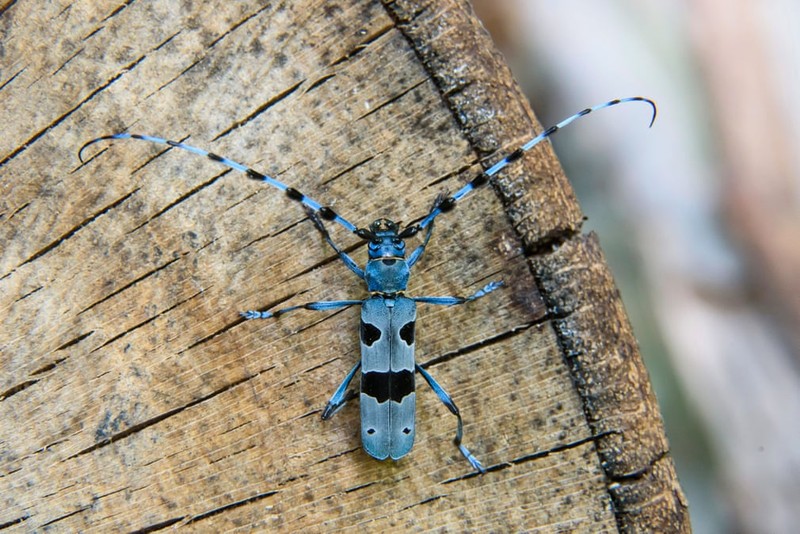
<box><xmin>78</xmin><ymin>96</ymin><xmax>657</xmax><ymax>473</ymax></box>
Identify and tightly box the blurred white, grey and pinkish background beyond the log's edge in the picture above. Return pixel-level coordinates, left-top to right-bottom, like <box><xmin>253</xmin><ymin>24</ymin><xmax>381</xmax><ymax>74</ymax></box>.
<box><xmin>474</xmin><ymin>0</ymin><xmax>800</xmax><ymax>533</ymax></box>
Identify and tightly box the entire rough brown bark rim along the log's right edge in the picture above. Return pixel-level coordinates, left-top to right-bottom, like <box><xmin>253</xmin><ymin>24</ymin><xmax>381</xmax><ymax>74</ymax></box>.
<box><xmin>384</xmin><ymin>0</ymin><xmax>691</xmax><ymax>532</ymax></box>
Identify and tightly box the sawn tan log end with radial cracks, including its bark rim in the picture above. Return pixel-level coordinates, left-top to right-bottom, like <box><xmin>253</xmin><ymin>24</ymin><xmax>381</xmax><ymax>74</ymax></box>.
<box><xmin>0</xmin><ymin>0</ymin><xmax>690</xmax><ymax>532</ymax></box>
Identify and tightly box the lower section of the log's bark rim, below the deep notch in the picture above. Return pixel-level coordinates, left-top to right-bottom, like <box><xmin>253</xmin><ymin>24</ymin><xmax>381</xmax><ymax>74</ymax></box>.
<box><xmin>531</xmin><ymin>234</ymin><xmax>691</xmax><ymax>532</ymax></box>
